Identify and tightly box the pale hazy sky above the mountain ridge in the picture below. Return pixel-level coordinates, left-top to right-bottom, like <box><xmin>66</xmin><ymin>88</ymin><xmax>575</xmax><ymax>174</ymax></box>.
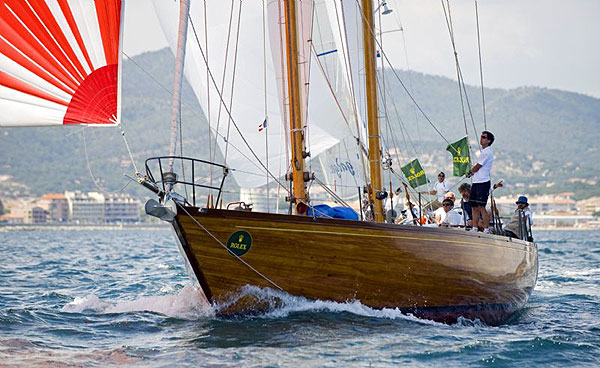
<box><xmin>123</xmin><ymin>0</ymin><xmax>600</xmax><ymax>97</ymax></box>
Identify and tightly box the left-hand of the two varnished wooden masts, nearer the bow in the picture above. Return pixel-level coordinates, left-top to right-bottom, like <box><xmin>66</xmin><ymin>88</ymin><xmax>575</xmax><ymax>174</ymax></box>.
<box><xmin>284</xmin><ymin>0</ymin><xmax>307</xmax><ymax>214</ymax></box>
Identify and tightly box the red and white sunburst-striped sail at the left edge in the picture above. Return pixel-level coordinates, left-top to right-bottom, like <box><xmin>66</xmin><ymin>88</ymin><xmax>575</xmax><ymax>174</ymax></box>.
<box><xmin>0</xmin><ymin>0</ymin><xmax>124</xmax><ymax>126</ymax></box>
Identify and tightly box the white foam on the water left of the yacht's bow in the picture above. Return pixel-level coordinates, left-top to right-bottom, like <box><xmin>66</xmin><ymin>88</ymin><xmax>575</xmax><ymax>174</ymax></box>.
<box><xmin>61</xmin><ymin>286</ymin><xmax>214</xmax><ymax>319</ymax></box>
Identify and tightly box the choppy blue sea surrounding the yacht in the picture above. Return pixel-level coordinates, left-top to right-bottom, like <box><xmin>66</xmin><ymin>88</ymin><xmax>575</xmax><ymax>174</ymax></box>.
<box><xmin>0</xmin><ymin>230</ymin><xmax>600</xmax><ymax>367</ymax></box>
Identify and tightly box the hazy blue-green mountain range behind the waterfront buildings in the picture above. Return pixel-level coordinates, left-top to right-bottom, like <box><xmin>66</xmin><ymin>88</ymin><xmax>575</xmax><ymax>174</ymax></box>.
<box><xmin>0</xmin><ymin>49</ymin><xmax>600</xmax><ymax>198</ymax></box>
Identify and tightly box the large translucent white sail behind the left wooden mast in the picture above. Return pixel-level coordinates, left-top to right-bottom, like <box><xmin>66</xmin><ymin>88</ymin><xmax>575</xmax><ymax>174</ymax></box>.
<box><xmin>153</xmin><ymin>0</ymin><xmax>352</xmax><ymax>188</ymax></box>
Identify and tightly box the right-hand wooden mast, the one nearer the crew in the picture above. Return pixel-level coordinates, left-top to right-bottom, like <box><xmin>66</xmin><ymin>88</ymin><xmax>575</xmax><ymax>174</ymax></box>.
<box><xmin>361</xmin><ymin>0</ymin><xmax>384</xmax><ymax>222</ymax></box>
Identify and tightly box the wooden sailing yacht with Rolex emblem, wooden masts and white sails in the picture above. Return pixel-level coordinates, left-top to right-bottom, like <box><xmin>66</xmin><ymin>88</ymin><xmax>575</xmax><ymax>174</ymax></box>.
<box><xmin>143</xmin><ymin>0</ymin><xmax>538</xmax><ymax>325</ymax></box>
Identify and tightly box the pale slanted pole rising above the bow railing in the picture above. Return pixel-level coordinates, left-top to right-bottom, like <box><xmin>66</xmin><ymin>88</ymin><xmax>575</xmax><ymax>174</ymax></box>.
<box><xmin>167</xmin><ymin>0</ymin><xmax>190</xmax><ymax>172</ymax></box>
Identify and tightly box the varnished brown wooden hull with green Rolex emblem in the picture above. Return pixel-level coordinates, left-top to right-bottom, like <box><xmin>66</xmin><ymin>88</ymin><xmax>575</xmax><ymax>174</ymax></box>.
<box><xmin>173</xmin><ymin>207</ymin><xmax>538</xmax><ymax>325</ymax></box>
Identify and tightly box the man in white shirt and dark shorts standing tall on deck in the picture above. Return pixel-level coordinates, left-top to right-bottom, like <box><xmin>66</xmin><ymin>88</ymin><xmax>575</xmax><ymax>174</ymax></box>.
<box><xmin>467</xmin><ymin>130</ymin><xmax>494</xmax><ymax>233</ymax></box>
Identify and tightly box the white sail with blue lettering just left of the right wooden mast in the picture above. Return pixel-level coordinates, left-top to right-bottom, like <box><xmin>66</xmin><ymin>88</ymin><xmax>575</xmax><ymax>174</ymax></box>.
<box><xmin>313</xmin><ymin>0</ymin><xmax>367</xmax><ymax>199</ymax></box>
